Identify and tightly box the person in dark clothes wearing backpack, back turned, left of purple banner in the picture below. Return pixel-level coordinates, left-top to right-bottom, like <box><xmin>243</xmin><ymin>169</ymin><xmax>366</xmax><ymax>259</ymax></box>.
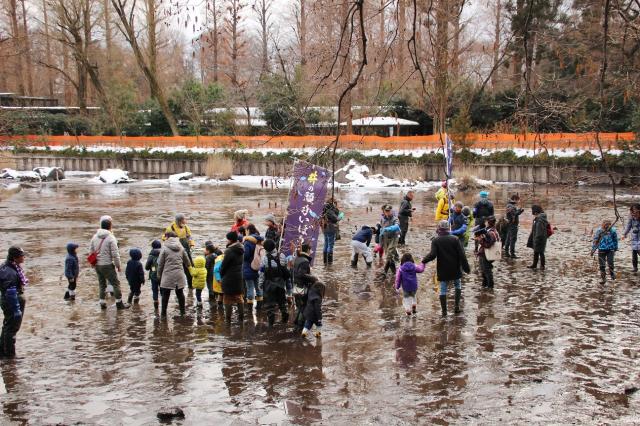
<box><xmin>259</xmin><ymin>240</ymin><xmax>289</xmax><ymax>327</ymax></box>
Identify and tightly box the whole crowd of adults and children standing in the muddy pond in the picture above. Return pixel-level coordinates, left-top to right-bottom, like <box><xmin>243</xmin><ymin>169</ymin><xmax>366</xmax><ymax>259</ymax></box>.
<box><xmin>0</xmin><ymin>187</ymin><xmax>640</xmax><ymax>357</ymax></box>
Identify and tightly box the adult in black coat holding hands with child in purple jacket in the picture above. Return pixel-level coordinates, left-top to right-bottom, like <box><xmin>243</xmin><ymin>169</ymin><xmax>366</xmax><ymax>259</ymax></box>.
<box><xmin>422</xmin><ymin>220</ymin><xmax>471</xmax><ymax>317</ymax></box>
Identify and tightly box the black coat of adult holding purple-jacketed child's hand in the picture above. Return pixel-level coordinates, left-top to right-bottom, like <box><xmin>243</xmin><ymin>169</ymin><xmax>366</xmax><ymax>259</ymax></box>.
<box><xmin>422</xmin><ymin>231</ymin><xmax>471</xmax><ymax>281</ymax></box>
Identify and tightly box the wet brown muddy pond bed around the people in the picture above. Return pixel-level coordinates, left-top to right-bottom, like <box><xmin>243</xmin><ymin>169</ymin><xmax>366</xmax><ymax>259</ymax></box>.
<box><xmin>0</xmin><ymin>179</ymin><xmax>640</xmax><ymax>425</ymax></box>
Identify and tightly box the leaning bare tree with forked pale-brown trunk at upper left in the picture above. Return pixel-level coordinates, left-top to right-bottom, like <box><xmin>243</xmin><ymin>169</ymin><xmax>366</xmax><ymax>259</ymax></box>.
<box><xmin>111</xmin><ymin>0</ymin><xmax>179</xmax><ymax>136</ymax></box>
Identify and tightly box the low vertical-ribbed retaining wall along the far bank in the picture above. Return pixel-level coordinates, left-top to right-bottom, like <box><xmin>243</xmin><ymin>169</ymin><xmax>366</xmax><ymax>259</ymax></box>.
<box><xmin>10</xmin><ymin>154</ymin><xmax>640</xmax><ymax>184</ymax></box>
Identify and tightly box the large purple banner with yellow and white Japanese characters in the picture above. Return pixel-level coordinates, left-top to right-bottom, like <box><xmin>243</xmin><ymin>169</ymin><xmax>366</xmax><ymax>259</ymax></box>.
<box><xmin>280</xmin><ymin>161</ymin><xmax>331</xmax><ymax>259</ymax></box>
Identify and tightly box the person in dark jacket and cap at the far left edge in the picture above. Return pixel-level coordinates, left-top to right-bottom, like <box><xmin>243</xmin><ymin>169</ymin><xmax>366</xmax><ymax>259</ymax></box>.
<box><xmin>0</xmin><ymin>246</ymin><xmax>29</xmax><ymax>358</ymax></box>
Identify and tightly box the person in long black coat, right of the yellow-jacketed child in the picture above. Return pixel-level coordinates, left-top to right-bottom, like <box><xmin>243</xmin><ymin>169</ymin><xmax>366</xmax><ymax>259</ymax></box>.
<box><xmin>220</xmin><ymin>232</ymin><xmax>244</xmax><ymax>322</ymax></box>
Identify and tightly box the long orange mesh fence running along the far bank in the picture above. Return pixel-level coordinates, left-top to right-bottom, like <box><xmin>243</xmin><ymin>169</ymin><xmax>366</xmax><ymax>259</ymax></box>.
<box><xmin>3</xmin><ymin>133</ymin><xmax>635</xmax><ymax>151</ymax></box>
